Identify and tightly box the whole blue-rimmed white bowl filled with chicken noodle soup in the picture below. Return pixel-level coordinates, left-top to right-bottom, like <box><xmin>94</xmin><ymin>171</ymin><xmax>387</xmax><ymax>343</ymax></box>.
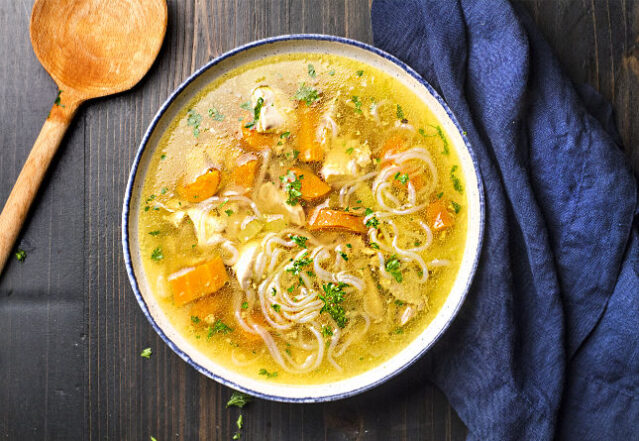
<box><xmin>122</xmin><ymin>35</ymin><xmax>483</xmax><ymax>402</ymax></box>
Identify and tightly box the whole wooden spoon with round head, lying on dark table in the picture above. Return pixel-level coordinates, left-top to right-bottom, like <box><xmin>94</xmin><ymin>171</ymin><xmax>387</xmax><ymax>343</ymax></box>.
<box><xmin>0</xmin><ymin>0</ymin><xmax>167</xmax><ymax>273</ymax></box>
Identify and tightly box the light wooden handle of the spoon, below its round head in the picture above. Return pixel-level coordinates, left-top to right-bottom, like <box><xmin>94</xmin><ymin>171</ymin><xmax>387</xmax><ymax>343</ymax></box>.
<box><xmin>0</xmin><ymin>94</ymin><xmax>81</xmax><ymax>274</ymax></box>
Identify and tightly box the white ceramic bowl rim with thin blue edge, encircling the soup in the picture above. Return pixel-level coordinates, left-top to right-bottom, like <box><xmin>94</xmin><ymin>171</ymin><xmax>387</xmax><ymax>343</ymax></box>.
<box><xmin>122</xmin><ymin>35</ymin><xmax>484</xmax><ymax>402</ymax></box>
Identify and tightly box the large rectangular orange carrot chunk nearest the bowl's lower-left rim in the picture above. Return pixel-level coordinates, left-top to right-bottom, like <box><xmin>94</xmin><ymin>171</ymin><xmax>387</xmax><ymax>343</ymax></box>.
<box><xmin>168</xmin><ymin>257</ymin><xmax>229</xmax><ymax>306</ymax></box>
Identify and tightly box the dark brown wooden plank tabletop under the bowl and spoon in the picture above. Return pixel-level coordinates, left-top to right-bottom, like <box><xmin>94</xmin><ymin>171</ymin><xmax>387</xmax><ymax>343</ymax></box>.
<box><xmin>0</xmin><ymin>0</ymin><xmax>639</xmax><ymax>441</ymax></box>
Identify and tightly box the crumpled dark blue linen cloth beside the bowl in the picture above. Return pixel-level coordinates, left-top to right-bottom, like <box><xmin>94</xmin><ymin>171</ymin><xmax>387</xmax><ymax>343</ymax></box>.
<box><xmin>372</xmin><ymin>0</ymin><xmax>639</xmax><ymax>441</ymax></box>
